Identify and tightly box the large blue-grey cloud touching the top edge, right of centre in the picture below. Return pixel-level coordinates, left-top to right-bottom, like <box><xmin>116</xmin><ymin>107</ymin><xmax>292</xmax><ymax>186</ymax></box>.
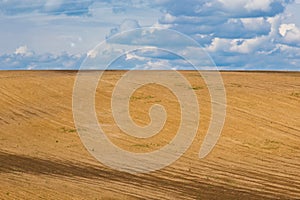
<box><xmin>156</xmin><ymin>0</ymin><xmax>289</xmax><ymax>38</ymax></box>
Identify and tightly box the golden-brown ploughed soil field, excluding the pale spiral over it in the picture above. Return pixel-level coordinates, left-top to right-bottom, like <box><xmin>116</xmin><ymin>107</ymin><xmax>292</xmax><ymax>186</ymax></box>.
<box><xmin>0</xmin><ymin>71</ymin><xmax>300</xmax><ymax>199</ymax></box>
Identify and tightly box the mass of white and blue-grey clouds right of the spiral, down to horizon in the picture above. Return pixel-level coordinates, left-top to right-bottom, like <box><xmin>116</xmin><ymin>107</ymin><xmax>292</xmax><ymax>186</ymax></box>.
<box><xmin>149</xmin><ymin>0</ymin><xmax>300</xmax><ymax>70</ymax></box>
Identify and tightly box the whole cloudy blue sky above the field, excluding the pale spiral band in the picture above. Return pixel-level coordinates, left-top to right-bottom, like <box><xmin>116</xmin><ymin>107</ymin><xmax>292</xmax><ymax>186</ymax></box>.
<box><xmin>0</xmin><ymin>0</ymin><xmax>300</xmax><ymax>71</ymax></box>
